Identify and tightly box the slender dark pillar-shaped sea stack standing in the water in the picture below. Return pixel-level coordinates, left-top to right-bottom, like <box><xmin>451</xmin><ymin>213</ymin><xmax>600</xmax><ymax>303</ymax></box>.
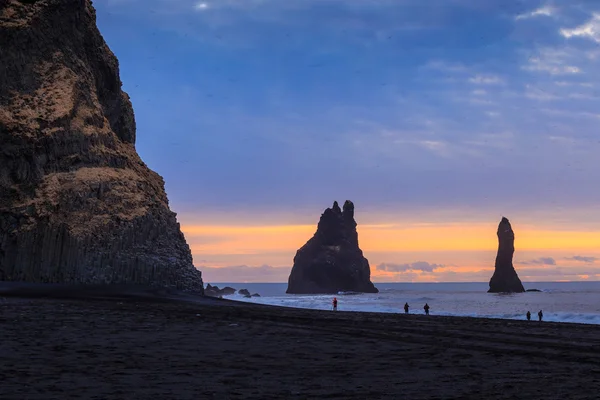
<box><xmin>488</xmin><ymin>217</ymin><xmax>525</xmax><ymax>293</ymax></box>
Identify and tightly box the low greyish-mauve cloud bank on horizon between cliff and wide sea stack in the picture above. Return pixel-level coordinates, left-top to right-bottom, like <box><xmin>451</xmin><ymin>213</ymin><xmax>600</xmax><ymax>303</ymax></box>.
<box><xmin>196</xmin><ymin>265</ymin><xmax>291</xmax><ymax>283</ymax></box>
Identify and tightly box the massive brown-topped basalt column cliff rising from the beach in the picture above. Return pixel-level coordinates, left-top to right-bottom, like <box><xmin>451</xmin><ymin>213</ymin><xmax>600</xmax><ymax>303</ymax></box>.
<box><xmin>0</xmin><ymin>0</ymin><xmax>203</xmax><ymax>293</ymax></box>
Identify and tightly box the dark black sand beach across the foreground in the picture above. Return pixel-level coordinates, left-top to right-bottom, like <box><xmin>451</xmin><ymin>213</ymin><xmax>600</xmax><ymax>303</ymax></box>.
<box><xmin>0</xmin><ymin>285</ymin><xmax>600</xmax><ymax>400</ymax></box>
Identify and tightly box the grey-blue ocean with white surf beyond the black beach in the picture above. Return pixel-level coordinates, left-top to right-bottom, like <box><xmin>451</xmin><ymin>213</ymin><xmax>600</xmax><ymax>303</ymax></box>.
<box><xmin>215</xmin><ymin>282</ymin><xmax>600</xmax><ymax>324</ymax></box>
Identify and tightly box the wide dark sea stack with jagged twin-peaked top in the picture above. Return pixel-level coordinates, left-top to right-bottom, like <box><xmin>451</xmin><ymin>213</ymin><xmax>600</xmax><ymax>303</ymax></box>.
<box><xmin>287</xmin><ymin>200</ymin><xmax>378</xmax><ymax>294</ymax></box>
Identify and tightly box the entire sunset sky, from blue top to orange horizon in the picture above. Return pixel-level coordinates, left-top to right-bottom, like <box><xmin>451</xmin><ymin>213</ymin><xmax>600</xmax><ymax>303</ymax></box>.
<box><xmin>94</xmin><ymin>0</ymin><xmax>600</xmax><ymax>283</ymax></box>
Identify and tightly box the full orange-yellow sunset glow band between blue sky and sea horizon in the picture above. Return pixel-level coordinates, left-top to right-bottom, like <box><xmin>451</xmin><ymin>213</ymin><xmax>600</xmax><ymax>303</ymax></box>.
<box><xmin>182</xmin><ymin>223</ymin><xmax>600</xmax><ymax>282</ymax></box>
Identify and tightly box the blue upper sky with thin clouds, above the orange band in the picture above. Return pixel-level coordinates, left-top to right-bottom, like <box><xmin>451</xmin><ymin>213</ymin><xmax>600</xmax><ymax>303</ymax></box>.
<box><xmin>94</xmin><ymin>0</ymin><xmax>600</xmax><ymax>223</ymax></box>
